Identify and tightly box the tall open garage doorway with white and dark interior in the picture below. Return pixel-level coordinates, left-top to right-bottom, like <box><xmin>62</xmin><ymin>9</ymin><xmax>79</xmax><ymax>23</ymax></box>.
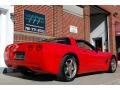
<box><xmin>90</xmin><ymin>6</ymin><xmax>108</xmax><ymax>52</ymax></box>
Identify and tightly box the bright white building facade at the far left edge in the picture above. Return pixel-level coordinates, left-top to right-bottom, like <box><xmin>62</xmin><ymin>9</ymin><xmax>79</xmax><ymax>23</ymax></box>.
<box><xmin>0</xmin><ymin>6</ymin><xmax>14</xmax><ymax>71</ymax></box>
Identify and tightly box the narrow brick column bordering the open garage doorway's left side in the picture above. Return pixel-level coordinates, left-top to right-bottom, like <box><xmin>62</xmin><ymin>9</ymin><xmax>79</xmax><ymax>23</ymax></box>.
<box><xmin>84</xmin><ymin>6</ymin><xmax>90</xmax><ymax>41</ymax></box>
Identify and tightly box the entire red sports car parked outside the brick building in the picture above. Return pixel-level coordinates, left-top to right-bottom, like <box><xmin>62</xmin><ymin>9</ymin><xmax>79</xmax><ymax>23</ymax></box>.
<box><xmin>4</xmin><ymin>37</ymin><xmax>117</xmax><ymax>81</ymax></box>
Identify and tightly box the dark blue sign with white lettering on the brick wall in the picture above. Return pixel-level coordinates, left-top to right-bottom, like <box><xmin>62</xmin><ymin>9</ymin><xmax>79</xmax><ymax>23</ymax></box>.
<box><xmin>24</xmin><ymin>10</ymin><xmax>45</xmax><ymax>33</ymax></box>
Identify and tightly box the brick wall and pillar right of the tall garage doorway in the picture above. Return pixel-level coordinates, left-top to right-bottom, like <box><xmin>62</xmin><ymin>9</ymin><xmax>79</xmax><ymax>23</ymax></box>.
<box><xmin>99</xmin><ymin>5</ymin><xmax>120</xmax><ymax>54</ymax></box>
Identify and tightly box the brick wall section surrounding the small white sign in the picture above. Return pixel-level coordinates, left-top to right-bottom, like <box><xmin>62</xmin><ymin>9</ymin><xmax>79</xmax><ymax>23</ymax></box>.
<box><xmin>63</xmin><ymin>11</ymin><xmax>84</xmax><ymax>39</ymax></box>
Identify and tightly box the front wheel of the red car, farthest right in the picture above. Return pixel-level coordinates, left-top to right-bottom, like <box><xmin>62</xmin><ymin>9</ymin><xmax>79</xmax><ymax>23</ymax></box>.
<box><xmin>108</xmin><ymin>56</ymin><xmax>117</xmax><ymax>73</ymax></box>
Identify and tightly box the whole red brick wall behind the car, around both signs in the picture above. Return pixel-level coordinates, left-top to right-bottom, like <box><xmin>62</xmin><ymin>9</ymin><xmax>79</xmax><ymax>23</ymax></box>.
<box><xmin>14</xmin><ymin>5</ymin><xmax>84</xmax><ymax>42</ymax></box>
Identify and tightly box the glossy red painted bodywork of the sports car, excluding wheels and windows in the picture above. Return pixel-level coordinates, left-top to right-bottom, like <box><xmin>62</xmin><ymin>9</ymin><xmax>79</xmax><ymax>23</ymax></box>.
<box><xmin>4</xmin><ymin>38</ymin><xmax>116</xmax><ymax>74</ymax></box>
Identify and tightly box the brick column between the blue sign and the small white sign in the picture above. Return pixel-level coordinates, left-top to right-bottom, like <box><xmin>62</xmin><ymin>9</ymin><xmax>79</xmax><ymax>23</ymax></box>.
<box><xmin>53</xmin><ymin>5</ymin><xmax>64</xmax><ymax>37</ymax></box>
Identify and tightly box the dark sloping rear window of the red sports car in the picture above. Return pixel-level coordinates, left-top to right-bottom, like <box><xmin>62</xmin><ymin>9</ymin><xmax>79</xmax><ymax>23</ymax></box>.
<box><xmin>41</xmin><ymin>38</ymin><xmax>70</xmax><ymax>45</ymax></box>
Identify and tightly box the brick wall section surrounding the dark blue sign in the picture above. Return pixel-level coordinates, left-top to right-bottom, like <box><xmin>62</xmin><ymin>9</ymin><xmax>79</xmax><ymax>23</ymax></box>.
<box><xmin>14</xmin><ymin>5</ymin><xmax>53</xmax><ymax>42</ymax></box>
